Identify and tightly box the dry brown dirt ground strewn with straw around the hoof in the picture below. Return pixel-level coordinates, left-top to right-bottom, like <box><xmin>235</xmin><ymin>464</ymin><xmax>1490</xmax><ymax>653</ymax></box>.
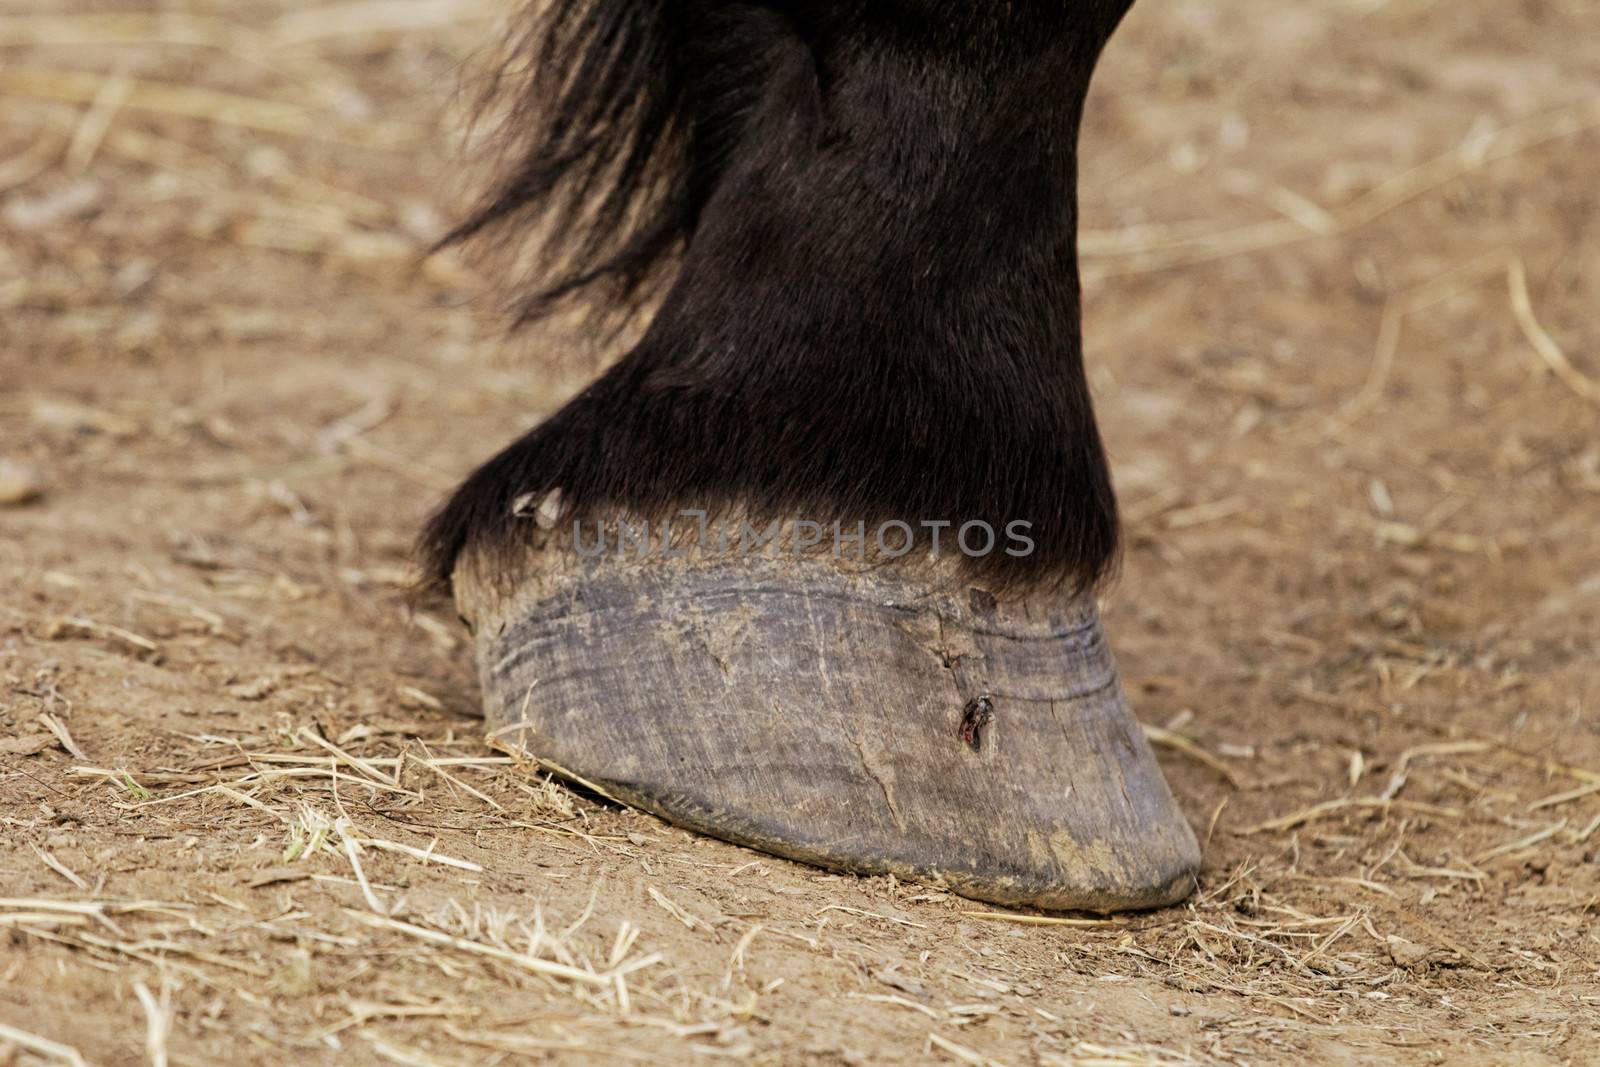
<box><xmin>0</xmin><ymin>0</ymin><xmax>1600</xmax><ymax>1067</ymax></box>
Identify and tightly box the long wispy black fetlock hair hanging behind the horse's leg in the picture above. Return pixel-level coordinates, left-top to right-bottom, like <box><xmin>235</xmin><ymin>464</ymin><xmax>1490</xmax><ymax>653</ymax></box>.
<box><xmin>437</xmin><ymin>0</ymin><xmax>770</xmax><ymax>325</ymax></box>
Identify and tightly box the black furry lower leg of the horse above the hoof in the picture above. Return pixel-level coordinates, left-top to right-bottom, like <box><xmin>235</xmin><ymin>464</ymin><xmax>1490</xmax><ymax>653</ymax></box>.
<box><xmin>422</xmin><ymin>0</ymin><xmax>1131</xmax><ymax>598</ymax></box>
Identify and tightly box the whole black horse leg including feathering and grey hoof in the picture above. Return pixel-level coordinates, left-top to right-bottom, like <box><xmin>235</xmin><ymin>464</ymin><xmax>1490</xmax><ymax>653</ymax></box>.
<box><xmin>422</xmin><ymin>0</ymin><xmax>1200</xmax><ymax>912</ymax></box>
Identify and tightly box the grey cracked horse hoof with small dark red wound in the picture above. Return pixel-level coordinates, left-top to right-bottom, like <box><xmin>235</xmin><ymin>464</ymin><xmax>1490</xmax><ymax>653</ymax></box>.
<box><xmin>456</xmin><ymin>552</ymin><xmax>1200</xmax><ymax>912</ymax></box>
